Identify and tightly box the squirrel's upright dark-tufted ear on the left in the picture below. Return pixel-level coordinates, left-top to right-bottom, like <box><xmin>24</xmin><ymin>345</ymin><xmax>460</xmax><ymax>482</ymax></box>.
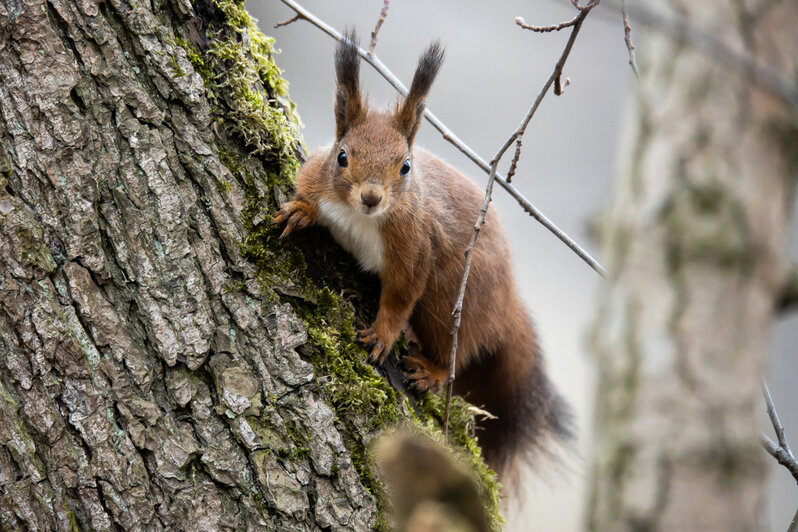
<box><xmin>335</xmin><ymin>30</ymin><xmax>366</xmax><ymax>140</ymax></box>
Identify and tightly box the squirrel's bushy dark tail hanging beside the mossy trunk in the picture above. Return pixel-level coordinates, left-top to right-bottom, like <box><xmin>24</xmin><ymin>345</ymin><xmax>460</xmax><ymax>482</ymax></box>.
<box><xmin>455</xmin><ymin>343</ymin><xmax>573</xmax><ymax>483</ymax></box>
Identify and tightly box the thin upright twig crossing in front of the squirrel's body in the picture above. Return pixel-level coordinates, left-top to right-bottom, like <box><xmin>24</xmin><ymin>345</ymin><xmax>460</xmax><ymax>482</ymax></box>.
<box><xmin>443</xmin><ymin>0</ymin><xmax>600</xmax><ymax>438</ymax></box>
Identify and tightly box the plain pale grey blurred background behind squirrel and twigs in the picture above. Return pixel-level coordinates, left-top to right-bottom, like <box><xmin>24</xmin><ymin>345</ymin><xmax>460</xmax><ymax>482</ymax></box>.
<box><xmin>247</xmin><ymin>0</ymin><xmax>798</xmax><ymax>532</ymax></box>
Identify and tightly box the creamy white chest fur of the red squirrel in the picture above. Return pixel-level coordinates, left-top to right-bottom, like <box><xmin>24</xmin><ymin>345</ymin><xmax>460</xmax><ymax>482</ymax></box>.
<box><xmin>319</xmin><ymin>200</ymin><xmax>383</xmax><ymax>272</ymax></box>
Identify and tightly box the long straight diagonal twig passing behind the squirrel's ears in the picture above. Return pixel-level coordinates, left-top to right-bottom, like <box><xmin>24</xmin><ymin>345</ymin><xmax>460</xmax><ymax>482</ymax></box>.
<box><xmin>280</xmin><ymin>0</ymin><xmax>607</xmax><ymax>277</ymax></box>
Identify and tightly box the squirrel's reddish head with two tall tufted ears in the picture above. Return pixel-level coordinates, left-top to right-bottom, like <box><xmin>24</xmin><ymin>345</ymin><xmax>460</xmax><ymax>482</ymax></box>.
<box><xmin>328</xmin><ymin>32</ymin><xmax>443</xmax><ymax>216</ymax></box>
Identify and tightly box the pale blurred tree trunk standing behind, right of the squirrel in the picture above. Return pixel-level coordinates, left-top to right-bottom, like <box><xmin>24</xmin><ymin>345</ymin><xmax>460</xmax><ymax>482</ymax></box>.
<box><xmin>588</xmin><ymin>1</ymin><xmax>798</xmax><ymax>531</ymax></box>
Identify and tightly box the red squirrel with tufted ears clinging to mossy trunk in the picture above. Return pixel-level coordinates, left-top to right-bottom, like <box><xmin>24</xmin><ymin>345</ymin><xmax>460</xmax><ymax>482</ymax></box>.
<box><xmin>274</xmin><ymin>34</ymin><xmax>570</xmax><ymax>478</ymax></box>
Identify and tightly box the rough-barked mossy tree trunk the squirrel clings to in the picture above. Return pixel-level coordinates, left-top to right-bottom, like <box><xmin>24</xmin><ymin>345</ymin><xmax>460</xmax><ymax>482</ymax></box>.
<box><xmin>0</xmin><ymin>0</ymin><xmax>497</xmax><ymax>530</ymax></box>
